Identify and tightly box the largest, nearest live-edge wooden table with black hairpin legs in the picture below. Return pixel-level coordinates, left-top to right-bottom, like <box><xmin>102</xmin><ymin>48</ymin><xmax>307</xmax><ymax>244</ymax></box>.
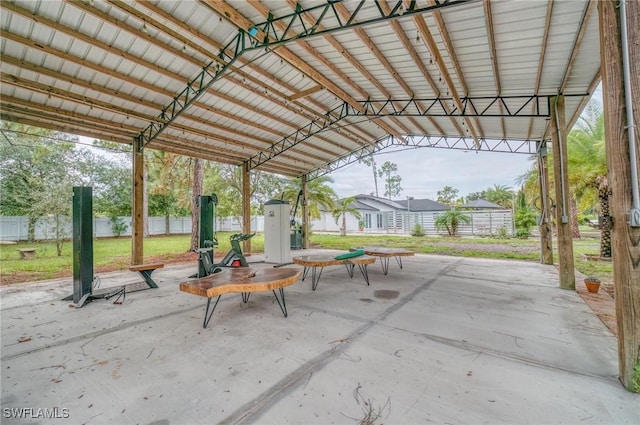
<box><xmin>180</xmin><ymin>267</ymin><xmax>302</xmax><ymax>328</ymax></box>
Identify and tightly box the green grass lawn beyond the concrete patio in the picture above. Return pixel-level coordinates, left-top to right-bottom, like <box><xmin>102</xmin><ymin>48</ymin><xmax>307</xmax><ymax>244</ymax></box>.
<box><xmin>0</xmin><ymin>232</ymin><xmax>612</xmax><ymax>284</ymax></box>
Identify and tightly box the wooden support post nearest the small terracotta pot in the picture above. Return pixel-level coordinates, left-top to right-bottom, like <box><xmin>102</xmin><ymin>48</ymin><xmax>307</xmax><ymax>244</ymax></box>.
<box><xmin>549</xmin><ymin>96</ymin><xmax>576</xmax><ymax>289</ymax></box>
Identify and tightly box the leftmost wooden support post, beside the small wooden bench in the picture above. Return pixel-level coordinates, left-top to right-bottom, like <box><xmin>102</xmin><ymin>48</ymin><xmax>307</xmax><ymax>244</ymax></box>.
<box><xmin>131</xmin><ymin>140</ymin><xmax>144</xmax><ymax>264</ymax></box>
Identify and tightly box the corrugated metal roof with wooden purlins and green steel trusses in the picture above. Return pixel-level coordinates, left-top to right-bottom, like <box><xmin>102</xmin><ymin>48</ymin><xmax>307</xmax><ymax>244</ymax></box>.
<box><xmin>0</xmin><ymin>0</ymin><xmax>600</xmax><ymax>177</ymax></box>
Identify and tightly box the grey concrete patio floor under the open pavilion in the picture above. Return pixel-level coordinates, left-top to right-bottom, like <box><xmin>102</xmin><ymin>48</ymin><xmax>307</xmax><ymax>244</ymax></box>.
<box><xmin>0</xmin><ymin>250</ymin><xmax>640</xmax><ymax>425</ymax></box>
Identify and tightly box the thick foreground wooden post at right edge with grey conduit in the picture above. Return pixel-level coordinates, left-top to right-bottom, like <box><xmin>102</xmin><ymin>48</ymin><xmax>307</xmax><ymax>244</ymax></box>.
<box><xmin>598</xmin><ymin>1</ymin><xmax>640</xmax><ymax>390</ymax></box>
